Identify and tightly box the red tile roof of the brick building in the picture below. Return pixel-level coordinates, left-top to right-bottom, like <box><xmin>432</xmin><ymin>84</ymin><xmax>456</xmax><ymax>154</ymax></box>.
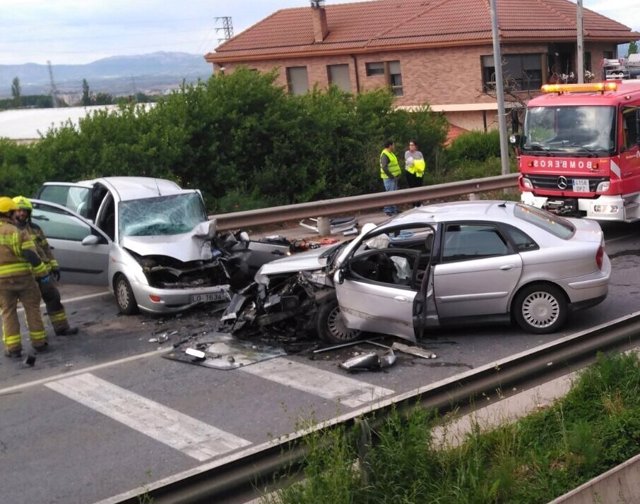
<box><xmin>205</xmin><ymin>0</ymin><xmax>640</xmax><ymax>63</ymax></box>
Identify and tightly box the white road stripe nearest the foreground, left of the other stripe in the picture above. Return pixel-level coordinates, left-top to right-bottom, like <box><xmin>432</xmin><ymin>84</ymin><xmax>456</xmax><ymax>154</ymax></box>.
<box><xmin>46</xmin><ymin>373</ymin><xmax>251</xmax><ymax>462</ymax></box>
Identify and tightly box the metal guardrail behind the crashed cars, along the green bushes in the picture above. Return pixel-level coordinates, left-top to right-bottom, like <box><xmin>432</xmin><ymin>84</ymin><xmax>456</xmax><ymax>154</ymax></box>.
<box><xmin>211</xmin><ymin>173</ymin><xmax>518</xmax><ymax>231</ymax></box>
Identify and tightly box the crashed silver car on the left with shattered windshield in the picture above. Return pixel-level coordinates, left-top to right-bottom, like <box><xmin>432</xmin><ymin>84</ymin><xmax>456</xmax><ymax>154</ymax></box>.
<box><xmin>32</xmin><ymin>177</ymin><xmax>284</xmax><ymax>314</ymax></box>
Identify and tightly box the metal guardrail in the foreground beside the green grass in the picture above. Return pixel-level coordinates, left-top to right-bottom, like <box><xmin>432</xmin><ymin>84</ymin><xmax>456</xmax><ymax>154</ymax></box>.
<box><xmin>98</xmin><ymin>312</ymin><xmax>640</xmax><ymax>504</ymax></box>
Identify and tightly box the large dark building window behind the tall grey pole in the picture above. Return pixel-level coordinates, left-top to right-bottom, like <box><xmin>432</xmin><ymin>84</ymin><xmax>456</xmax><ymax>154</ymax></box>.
<box><xmin>482</xmin><ymin>54</ymin><xmax>542</xmax><ymax>92</ymax></box>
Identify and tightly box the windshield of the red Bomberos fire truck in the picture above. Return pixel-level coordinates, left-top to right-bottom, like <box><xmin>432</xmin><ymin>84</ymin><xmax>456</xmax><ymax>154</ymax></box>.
<box><xmin>521</xmin><ymin>106</ymin><xmax>616</xmax><ymax>155</ymax></box>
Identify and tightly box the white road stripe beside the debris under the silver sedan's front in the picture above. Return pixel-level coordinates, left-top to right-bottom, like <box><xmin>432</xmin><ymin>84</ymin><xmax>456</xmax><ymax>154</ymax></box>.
<box><xmin>239</xmin><ymin>358</ymin><xmax>394</xmax><ymax>408</ymax></box>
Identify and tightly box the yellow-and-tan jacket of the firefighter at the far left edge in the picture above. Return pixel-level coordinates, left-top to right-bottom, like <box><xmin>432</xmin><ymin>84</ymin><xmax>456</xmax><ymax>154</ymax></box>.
<box><xmin>0</xmin><ymin>217</ymin><xmax>48</xmax><ymax>282</ymax></box>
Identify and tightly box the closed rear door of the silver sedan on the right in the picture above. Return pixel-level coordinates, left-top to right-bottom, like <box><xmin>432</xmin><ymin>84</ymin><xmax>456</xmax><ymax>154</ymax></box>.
<box><xmin>433</xmin><ymin>222</ymin><xmax>522</xmax><ymax>319</ymax></box>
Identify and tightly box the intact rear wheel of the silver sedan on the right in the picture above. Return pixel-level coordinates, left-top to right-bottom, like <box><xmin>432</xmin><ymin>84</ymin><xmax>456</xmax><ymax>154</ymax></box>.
<box><xmin>513</xmin><ymin>284</ymin><xmax>568</xmax><ymax>334</ymax></box>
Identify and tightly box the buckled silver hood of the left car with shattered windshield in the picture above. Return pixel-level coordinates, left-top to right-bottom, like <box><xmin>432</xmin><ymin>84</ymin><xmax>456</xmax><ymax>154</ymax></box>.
<box><xmin>120</xmin><ymin>233</ymin><xmax>213</xmax><ymax>262</ymax></box>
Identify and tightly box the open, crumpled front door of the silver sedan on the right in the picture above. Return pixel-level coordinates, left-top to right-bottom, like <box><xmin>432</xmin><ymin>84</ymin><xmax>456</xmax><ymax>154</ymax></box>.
<box><xmin>334</xmin><ymin>226</ymin><xmax>431</xmax><ymax>341</ymax></box>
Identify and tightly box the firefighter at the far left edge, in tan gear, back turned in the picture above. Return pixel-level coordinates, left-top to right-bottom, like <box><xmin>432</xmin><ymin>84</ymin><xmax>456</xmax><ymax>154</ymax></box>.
<box><xmin>0</xmin><ymin>196</ymin><xmax>49</xmax><ymax>358</ymax></box>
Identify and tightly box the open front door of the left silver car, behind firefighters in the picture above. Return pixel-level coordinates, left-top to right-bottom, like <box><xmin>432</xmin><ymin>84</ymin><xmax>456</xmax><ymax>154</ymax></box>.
<box><xmin>31</xmin><ymin>200</ymin><xmax>111</xmax><ymax>286</ymax></box>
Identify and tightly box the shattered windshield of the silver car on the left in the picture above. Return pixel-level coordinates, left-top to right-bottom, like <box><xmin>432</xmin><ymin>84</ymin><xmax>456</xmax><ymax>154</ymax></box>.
<box><xmin>119</xmin><ymin>192</ymin><xmax>207</xmax><ymax>236</ymax></box>
